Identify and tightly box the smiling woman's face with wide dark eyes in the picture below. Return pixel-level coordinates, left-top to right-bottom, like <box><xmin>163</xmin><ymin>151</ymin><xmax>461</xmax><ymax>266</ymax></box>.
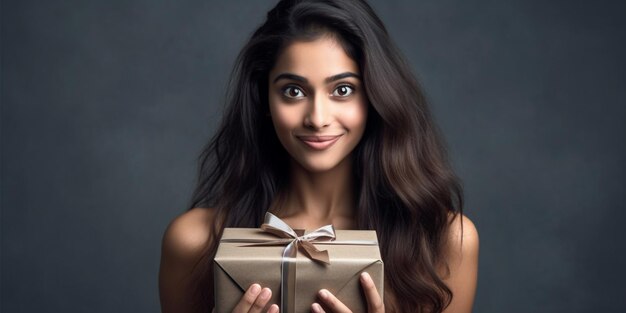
<box><xmin>269</xmin><ymin>36</ymin><xmax>367</xmax><ymax>172</ymax></box>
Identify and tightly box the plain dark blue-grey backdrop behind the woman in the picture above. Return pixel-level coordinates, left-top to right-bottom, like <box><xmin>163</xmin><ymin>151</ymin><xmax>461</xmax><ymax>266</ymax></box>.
<box><xmin>1</xmin><ymin>0</ymin><xmax>626</xmax><ymax>312</ymax></box>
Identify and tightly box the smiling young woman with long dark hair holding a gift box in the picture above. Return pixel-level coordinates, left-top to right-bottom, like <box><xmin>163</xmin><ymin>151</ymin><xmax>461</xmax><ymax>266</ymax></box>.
<box><xmin>159</xmin><ymin>0</ymin><xmax>478</xmax><ymax>312</ymax></box>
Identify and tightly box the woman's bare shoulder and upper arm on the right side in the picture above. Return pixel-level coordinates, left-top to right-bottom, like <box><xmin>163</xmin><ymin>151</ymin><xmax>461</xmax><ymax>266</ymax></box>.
<box><xmin>441</xmin><ymin>216</ymin><xmax>479</xmax><ymax>313</ymax></box>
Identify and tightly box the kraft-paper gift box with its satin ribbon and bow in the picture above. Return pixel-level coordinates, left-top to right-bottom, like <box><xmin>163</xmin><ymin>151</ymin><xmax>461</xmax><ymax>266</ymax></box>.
<box><xmin>214</xmin><ymin>213</ymin><xmax>383</xmax><ymax>313</ymax></box>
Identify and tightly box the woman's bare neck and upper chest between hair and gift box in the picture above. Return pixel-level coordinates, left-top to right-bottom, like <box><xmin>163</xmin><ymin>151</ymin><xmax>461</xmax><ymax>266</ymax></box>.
<box><xmin>280</xmin><ymin>157</ymin><xmax>355</xmax><ymax>229</ymax></box>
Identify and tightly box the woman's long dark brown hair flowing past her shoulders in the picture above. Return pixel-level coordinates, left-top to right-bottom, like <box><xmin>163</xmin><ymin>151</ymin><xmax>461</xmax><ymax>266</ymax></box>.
<box><xmin>190</xmin><ymin>0</ymin><xmax>463</xmax><ymax>312</ymax></box>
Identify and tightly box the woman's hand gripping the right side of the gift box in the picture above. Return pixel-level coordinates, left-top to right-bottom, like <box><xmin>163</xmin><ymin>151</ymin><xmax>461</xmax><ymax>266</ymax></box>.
<box><xmin>311</xmin><ymin>272</ymin><xmax>385</xmax><ymax>313</ymax></box>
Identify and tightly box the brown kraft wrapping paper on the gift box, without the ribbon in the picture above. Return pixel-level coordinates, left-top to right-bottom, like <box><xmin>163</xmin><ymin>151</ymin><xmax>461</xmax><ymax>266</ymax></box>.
<box><xmin>213</xmin><ymin>228</ymin><xmax>384</xmax><ymax>313</ymax></box>
